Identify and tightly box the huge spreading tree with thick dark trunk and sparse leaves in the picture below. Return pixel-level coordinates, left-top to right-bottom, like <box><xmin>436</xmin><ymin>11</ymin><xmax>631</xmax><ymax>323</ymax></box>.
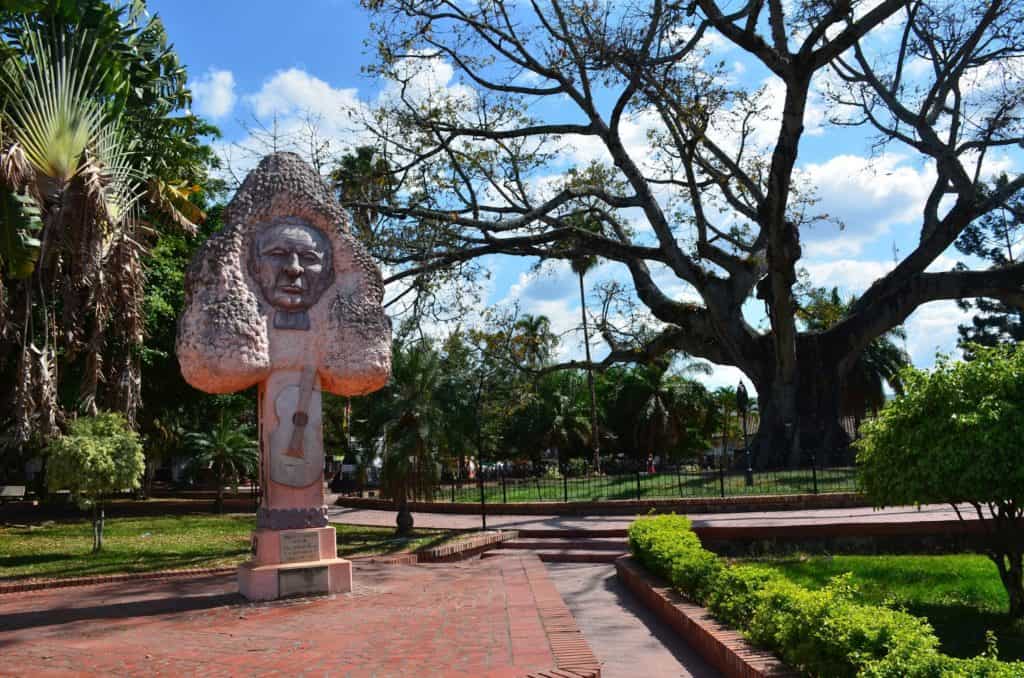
<box><xmin>353</xmin><ymin>0</ymin><xmax>1024</xmax><ymax>465</ymax></box>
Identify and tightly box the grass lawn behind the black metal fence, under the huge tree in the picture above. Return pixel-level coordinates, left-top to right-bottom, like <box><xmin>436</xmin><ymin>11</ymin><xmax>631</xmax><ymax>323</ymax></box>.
<box><xmin>435</xmin><ymin>468</ymin><xmax>856</xmax><ymax>504</ymax></box>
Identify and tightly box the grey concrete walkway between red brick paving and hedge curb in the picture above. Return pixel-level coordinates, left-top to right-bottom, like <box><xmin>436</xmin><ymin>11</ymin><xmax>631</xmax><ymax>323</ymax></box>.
<box><xmin>548</xmin><ymin>562</ymin><xmax>720</xmax><ymax>678</ymax></box>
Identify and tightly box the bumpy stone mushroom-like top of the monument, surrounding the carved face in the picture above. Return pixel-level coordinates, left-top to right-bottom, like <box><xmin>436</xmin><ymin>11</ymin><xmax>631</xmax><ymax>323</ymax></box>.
<box><xmin>177</xmin><ymin>153</ymin><xmax>391</xmax><ymax>395</ymax></box>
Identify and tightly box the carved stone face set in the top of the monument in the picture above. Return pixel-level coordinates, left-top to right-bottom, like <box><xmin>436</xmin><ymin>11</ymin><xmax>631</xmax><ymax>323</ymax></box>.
<box><xmin>252</xmin><ymin>223</ymin><xmax>334</xmax><ymax>312</ymax></box>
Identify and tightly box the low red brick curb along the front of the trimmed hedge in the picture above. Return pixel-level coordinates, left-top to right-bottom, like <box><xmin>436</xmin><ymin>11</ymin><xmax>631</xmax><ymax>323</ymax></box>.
<box><xmin>615</xmin><ymin>556</ymin><xmax>800</xmax><ymax>678</ymax></box>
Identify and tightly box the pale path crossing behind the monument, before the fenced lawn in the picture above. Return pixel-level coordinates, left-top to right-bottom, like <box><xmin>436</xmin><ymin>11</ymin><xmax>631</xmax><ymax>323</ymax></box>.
<box><xmin>329</xmin><ymin>499</ymin><xmax>973</xmax><ymax>529</ymax></box>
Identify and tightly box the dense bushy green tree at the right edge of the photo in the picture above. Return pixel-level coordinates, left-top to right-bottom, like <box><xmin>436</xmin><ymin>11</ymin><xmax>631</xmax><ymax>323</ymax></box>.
<box><xmin>857</xmin><ymin>344</ymin><xmax>1024</xmax><ymax>619</ymax></box>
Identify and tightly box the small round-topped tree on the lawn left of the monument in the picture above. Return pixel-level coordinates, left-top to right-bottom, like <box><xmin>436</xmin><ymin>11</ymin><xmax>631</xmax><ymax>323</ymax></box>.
<box><xmin>46</xmin><ymin>412</ymin><xmax>145</xmax><ymax>553</ymax></box>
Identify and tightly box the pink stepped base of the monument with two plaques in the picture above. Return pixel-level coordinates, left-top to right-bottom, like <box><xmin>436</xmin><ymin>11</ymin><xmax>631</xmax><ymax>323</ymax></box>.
<box><xmin>239</xmin><ymin>527</ymin><xmax>352</xmax><ymax>600</ymax></box>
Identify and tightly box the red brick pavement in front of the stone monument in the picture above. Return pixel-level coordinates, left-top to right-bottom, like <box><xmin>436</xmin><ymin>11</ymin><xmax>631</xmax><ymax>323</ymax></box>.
<box><xmin>0</xmin><ymin>556</ymin><xmax>596</xmax><ymax>677</ymax></box>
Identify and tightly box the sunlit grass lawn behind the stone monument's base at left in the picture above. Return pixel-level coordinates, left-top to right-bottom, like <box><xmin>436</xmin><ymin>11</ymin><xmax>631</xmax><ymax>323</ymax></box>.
<box><xmin>0</xmin><ymin>515</ymin><xmax>459</xmax><ymax>581</ymax></box>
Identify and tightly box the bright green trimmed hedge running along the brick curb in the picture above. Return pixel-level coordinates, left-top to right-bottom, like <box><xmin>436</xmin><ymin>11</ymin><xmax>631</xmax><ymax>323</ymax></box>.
<box><xmin>630</xmin><ymin>515</ymin><xmax>1024</xmax><ymax>678</ymax></box>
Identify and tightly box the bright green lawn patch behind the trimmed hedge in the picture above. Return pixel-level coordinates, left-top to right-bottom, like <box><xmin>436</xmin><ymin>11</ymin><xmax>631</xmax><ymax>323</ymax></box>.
<box><xmin>760</xmin><ymin>555</ymin><xmax>1024</xmax><ymax>661</ymax></box>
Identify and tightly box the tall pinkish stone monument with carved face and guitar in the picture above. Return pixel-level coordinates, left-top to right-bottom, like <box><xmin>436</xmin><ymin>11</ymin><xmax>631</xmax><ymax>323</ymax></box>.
<box><xmin>177</xmin><ymin>153</ymin><xmax>391</xmax><ymax>597</ymax></box>
